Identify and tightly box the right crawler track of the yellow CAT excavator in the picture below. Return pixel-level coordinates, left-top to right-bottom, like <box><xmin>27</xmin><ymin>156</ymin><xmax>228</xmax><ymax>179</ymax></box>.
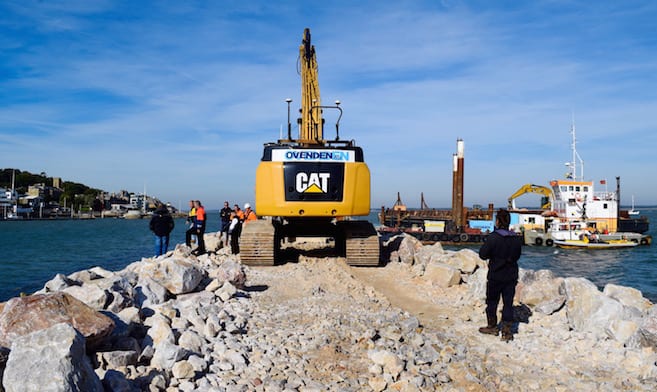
<box><xmin>338</xmin><ymin>221</ymin><xmax>380</xmax><ymax>266</ymax></box>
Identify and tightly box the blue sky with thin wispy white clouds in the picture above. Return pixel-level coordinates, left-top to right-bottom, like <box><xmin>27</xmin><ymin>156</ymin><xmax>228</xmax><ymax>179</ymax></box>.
<box><xmin>0</xmin><ymin>0</ymin><xmax>657</xmax><ymax>208</ymax></box>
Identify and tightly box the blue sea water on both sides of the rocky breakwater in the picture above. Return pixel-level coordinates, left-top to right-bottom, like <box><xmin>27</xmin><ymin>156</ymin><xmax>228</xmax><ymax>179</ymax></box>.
<box><xmin>0</xmin><ymin>208</ymin><xmax>657</xmax><ymax>302</ymax></box>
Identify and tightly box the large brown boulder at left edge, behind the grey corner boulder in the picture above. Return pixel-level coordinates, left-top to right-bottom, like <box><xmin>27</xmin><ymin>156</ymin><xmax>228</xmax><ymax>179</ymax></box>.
<box><xmin>0</xmin><ymin>292</ymin><xmax>114</xmax><ymax>348</ymax></box>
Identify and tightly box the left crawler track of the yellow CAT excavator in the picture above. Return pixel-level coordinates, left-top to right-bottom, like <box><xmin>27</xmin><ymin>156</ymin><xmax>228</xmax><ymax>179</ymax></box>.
<box><xmin>240</xmin><ymin>220</ymin><xmax>276</xmax><ymax>266</ymax></box>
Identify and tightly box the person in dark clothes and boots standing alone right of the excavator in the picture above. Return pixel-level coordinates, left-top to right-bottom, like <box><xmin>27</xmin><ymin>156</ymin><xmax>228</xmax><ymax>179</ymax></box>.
<box><xmin>479</xmin><ymin>209</ymin><xmax>522</xmax><ymax>341</ymax></box>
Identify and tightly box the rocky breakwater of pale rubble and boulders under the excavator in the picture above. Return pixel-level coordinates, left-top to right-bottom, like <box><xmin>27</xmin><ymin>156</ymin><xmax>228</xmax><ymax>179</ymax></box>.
<box><xmin>0</xmin><ymin>236</ymin><xmax>657</xmax><ymax>391</ymax></box>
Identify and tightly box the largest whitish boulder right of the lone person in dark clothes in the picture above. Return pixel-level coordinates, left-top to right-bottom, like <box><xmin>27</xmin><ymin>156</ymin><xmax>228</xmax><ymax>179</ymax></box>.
<box><xmin>564</xmin><ymin>278</ymin><xmax>623</xmax><ymax>337</ymax></box>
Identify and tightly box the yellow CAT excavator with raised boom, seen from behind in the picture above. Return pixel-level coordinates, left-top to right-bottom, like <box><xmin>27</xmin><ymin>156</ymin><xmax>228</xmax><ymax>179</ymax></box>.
<box><xmin>240</xmin><ymin>29</ymin><xmax>379</xmax><ymax>266</ymax></box>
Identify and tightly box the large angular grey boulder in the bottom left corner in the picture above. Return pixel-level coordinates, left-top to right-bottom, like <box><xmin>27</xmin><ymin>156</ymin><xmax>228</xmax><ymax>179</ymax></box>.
<box><xmin>3</xmin><ymin>323</ymin><xmax>103</xmax><ymax>392</ymax></box>
